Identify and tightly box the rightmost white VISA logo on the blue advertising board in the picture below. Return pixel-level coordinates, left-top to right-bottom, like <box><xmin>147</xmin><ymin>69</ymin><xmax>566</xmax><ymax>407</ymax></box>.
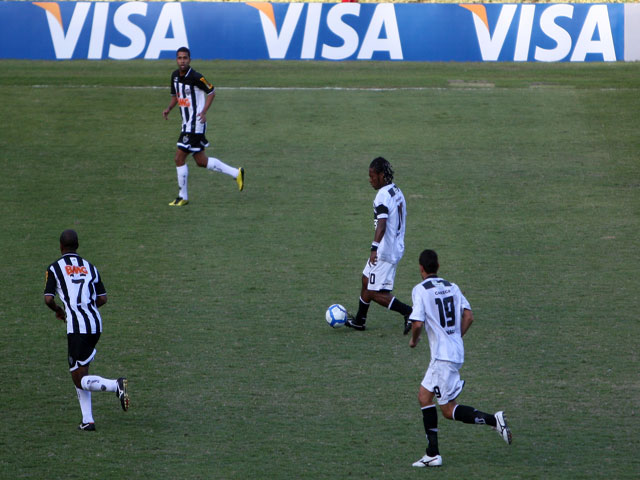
<box><xmin>460</xmin><ymin>4</ymin><xmax>616</xmax><ymax>62</ymax></box>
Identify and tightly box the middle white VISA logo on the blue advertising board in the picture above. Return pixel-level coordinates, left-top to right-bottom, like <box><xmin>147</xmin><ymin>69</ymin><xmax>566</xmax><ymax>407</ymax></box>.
<box><xmin>247</xmin><ymin>2</ymin><xmax>403</xmax><ymax>60</ymax></box>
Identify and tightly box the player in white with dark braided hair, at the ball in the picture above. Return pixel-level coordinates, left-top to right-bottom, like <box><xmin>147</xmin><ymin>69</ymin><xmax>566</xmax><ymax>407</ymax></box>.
<box><xmin>346</xmin><ymin>157</ymin><xmax>411</xmax><ymax>335</ymax></box>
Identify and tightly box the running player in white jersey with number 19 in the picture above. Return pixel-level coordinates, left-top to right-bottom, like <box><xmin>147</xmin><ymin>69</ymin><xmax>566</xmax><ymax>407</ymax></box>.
<box><xmin>409</xmin><ymin>250</ymin><xmax>511</xmax><ymax>467</ymax></box>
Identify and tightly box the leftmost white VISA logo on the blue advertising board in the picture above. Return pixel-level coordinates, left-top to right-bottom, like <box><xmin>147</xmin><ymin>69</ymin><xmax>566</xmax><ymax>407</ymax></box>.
<box><xmin>33</xmin><ymin>2</ymin><xmax>189</xmax><ymax>60</ymax></box>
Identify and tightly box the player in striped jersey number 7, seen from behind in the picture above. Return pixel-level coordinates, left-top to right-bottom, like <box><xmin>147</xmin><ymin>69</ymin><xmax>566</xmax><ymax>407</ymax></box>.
<box><xmin>44</xmin><ymin>230</ymin><xmax>129</xmax><ymax>431</ymax></box>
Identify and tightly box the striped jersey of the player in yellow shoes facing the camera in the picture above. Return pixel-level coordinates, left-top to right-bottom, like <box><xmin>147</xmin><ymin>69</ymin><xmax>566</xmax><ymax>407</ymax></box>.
<box><xmin>171</xmin><ymin>68</ymin><xmax>215</xmax><ymax>134</ymax></box>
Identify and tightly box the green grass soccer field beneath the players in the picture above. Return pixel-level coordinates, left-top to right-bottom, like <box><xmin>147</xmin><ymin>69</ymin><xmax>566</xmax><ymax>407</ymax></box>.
<box><xmin>0</xmin><ymin>61</ymin><xmax>640</xmax><ymax>480</ymax></box>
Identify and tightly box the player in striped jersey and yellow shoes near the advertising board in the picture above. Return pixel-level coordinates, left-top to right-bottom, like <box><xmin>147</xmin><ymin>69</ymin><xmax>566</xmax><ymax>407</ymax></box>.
<box><xmin>162</xmin><ymin>47</ymin><xmax>244</xmax><ymax>207</ymax></box>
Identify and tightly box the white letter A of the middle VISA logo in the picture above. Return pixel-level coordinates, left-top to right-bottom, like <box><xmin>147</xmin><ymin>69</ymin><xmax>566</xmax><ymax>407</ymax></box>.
<box><xmin>358</xmin><ymin>3</ymin><xmax>403</xmax><ymax>60</ymax></box>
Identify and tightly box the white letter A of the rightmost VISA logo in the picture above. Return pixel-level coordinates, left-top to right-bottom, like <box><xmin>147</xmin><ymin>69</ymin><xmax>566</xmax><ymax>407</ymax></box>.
<box><xmin>571</xmin><ymin>5</ymin><xmax>616</xmax><ymax>62</ymax></box>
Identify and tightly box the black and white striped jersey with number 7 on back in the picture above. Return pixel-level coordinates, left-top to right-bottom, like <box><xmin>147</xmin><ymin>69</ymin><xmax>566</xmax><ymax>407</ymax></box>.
<box><xmin>44</xmin><ymin>253</ymin><xmax>107</xmax><ymax>333</ymax></box>
